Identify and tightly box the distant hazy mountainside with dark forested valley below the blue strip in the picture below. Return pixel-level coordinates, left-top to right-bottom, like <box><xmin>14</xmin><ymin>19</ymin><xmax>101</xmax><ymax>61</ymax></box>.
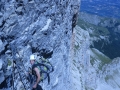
<box><xmin>78</xmin><ymin>12</ymin><xmax>120</xmax><ymax>59</ymax></box>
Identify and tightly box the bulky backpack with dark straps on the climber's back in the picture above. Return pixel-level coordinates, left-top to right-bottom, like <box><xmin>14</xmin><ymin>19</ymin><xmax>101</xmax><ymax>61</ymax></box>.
<box><xmin>32</xmin><ymin>58</ymin><xmax>54</xmax><ymax>84</ymax></box>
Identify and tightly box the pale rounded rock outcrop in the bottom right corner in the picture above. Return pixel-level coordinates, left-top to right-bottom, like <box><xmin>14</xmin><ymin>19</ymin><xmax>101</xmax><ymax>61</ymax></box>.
<box><xmin>98</xmin><ymin>57</ymin><xmax>120</xmax><ymax>90</ymax></box>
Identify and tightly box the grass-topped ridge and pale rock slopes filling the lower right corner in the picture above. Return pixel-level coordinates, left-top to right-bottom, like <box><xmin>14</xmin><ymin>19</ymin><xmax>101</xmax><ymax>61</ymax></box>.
<box><xmin>88</xmin><ymin>48</ymin><xmax>120</xmax><ymax>90</ymax></box>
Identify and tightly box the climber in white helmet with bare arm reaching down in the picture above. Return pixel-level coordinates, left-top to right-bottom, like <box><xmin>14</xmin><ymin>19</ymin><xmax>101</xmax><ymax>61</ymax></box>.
<box><xmin>30</xmin><ymin>55</ymin><xmax>43</xmax><ymax>90</ymax></box>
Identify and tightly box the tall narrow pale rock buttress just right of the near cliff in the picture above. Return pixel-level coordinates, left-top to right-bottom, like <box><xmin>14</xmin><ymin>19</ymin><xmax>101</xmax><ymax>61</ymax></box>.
<box><xmin>71</xmin><ymin>26</ymin><xmax>93</xmax><ymax>90</ymax></box>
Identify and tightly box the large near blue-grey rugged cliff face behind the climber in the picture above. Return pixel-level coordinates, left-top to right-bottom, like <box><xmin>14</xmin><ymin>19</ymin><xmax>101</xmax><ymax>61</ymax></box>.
<box><xmin>0</xmin><ymin>0</ymin><xmax>80</xmax><ymax>90</ymax></box>
